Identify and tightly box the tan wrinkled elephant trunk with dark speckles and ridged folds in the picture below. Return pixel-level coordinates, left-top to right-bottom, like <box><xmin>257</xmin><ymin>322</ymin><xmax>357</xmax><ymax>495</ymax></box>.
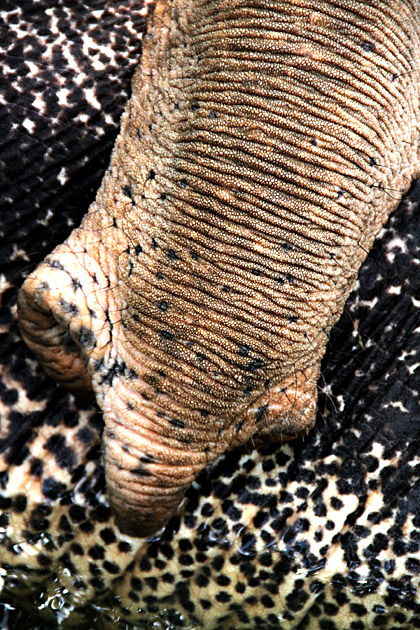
<box><xmin>18</xmin><ymin>0</ymin><xmax>420</xmax><ymax>536</ymax></box>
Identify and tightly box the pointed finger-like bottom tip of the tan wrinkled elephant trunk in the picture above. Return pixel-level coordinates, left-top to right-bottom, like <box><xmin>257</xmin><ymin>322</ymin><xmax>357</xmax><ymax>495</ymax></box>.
<box><xmin>104</xmin><ymin>396</ymin><xmax>215</xmax><ymax>537</ymax></box>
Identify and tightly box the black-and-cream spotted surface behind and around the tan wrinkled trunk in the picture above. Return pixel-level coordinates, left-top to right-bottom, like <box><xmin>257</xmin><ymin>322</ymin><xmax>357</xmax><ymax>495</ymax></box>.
<box><xmin>0</xmin><ymin>0</ymin><xmax>420</xmax><ymax>630</ymax></box>
